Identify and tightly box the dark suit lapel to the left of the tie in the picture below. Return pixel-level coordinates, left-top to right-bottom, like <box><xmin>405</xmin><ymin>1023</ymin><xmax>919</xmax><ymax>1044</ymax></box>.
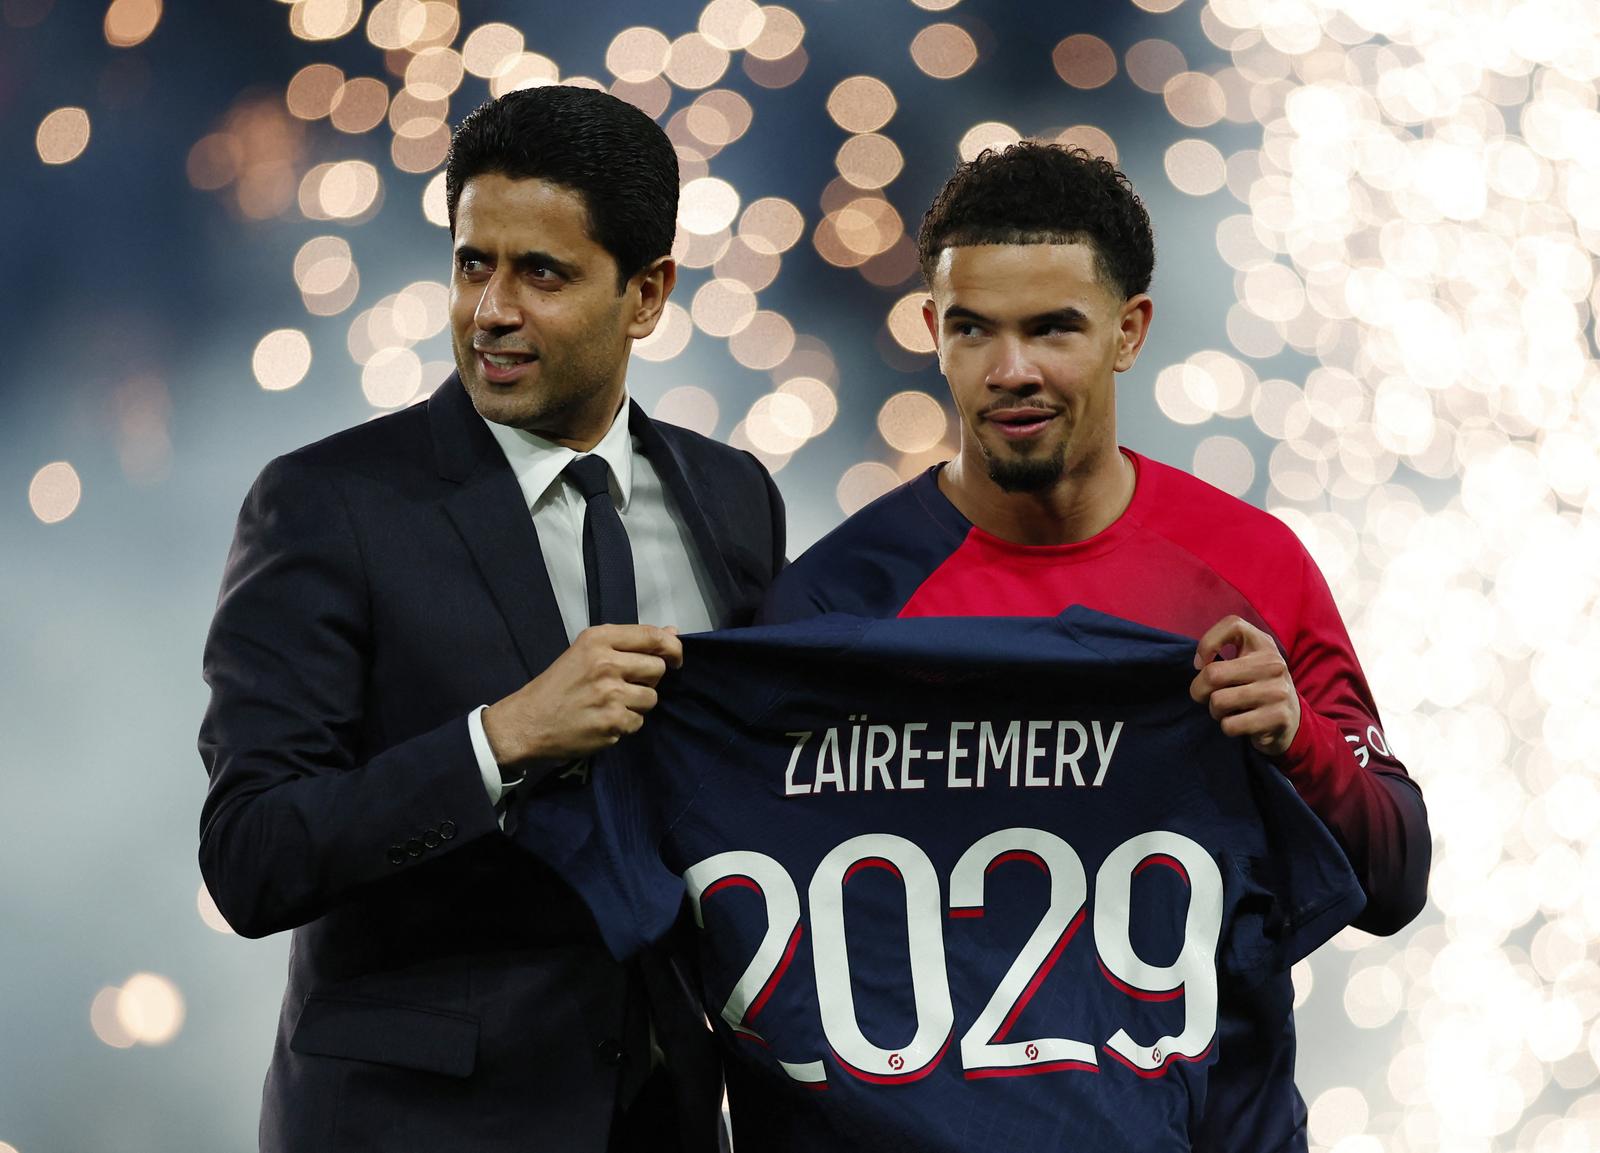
<box><xmin>427</xmin><ymin>373</ymin><xmax>566</xmax><ymax>676</ymax></box>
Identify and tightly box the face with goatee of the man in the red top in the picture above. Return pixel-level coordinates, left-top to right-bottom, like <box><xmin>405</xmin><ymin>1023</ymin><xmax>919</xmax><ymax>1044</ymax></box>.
<box><xmin>923</xmin><ymin>245</ymin><xmax>1150</xmax><ymax>493</ymax></box>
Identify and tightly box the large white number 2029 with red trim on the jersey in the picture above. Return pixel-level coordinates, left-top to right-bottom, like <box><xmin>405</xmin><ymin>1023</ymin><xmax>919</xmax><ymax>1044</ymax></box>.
<box><xmin>683</xmin><ymin>828</ymin><xmax>1222</xmax><ymax>1087</ymax></box>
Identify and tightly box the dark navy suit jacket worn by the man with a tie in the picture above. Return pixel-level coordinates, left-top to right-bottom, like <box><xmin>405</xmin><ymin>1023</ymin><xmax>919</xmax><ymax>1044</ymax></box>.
<box><xmin>200</xmin><ymin>376</ymin><xmax>784</xmax><ymax>1153</ymax></box>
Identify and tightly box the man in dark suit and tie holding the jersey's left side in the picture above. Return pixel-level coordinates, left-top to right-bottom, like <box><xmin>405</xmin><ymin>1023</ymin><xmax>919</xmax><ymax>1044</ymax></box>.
<box><xmin>200</xmin><ymin>86</ymin><xmax>784</xmax><ymax>1153</ymax></box>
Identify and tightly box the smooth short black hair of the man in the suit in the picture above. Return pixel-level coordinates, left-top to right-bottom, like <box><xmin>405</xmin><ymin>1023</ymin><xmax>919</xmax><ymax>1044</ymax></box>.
<box><xmin>445</xmin><ymin>85</ymin><xmax>678</xmax><ymax>291</ymax></box>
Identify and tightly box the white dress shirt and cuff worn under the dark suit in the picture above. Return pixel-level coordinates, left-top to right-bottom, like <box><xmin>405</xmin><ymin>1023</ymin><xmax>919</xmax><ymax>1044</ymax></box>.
<box><xmin>467</xmin><ymin>393</ymin><xmax>715</xmax><ymax>804</ymax></box>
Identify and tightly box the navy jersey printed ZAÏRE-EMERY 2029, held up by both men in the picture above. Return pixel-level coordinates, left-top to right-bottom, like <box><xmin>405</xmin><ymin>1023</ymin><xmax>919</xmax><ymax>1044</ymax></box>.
<box><xmin>517</xmin><ymin>609</ymin><xmax>1363</xmax><ymax>1153</ymax></box>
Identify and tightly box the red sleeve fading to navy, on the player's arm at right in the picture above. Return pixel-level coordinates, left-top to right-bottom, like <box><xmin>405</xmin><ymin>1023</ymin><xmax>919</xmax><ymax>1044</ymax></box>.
<box><xmin>1259</xmin><ymin>539</ymin><xmax>1432</xmax><ymax>934</ymax></box>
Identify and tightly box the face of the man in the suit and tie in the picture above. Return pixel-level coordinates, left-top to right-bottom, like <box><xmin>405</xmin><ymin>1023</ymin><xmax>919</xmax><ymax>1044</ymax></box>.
<box><xmin>450</xmin><ymin>173</ymin><xmax>672</xmax><ymax>449</ymax></box>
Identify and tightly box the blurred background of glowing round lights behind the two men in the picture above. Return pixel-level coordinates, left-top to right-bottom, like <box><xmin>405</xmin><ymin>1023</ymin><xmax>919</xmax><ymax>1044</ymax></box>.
<box><xmin>0</xmin><ymin>0</ymin><xmax>1600</xmax><ymax>1153</ymax></box>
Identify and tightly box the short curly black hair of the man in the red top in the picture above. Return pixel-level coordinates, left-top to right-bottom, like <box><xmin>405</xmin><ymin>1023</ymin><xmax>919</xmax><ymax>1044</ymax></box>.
<box><xmin>917</xmin><ymin>141</ymin><xmax>1155</xmax><ymax>299</ymax></box>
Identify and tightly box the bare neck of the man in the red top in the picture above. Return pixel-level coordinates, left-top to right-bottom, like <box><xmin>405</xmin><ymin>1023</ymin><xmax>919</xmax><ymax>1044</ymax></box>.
<box><xmin>939</xmin><ymin>449</ymin><xmax>1138</xmax><ymax>545</ymax></box>
